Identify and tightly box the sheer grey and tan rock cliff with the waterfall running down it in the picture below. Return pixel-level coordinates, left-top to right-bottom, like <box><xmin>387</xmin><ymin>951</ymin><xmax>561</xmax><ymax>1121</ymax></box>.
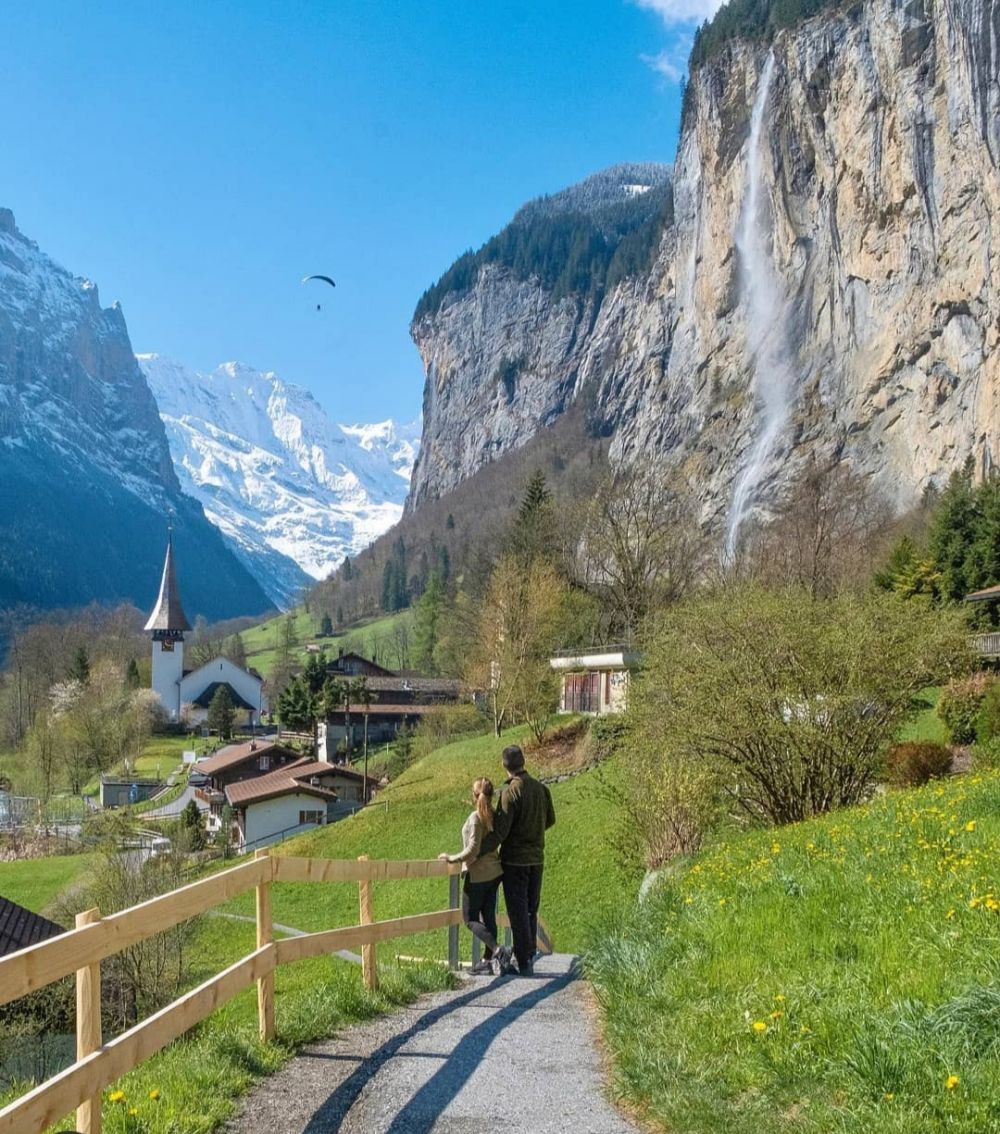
<box><xmin>410</xmin><ymin>0</ymin><xmax>1000</xmax><ymax>538</ymax></box>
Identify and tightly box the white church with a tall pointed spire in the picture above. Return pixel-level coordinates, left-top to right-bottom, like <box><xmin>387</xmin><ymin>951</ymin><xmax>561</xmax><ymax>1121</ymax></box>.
<box><xmin>145</xmin><ymin>532</ymin><xmax>268</xmax><ymax>727</ymax></box>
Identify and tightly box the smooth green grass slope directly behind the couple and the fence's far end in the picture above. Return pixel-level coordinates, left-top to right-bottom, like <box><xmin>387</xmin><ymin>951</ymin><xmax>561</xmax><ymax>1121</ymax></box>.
<box><xmin>216</xmin><ymin>729</ymin><xmax>638</xmax><ymax>958</ymax></box>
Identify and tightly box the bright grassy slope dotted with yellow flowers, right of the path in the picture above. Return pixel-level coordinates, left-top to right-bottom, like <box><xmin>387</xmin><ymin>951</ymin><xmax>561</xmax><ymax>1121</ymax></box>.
<box><xmin>587</xmin><ymin>773</ymin><xmax>1000</xmax><ymax>1134</ymax></box>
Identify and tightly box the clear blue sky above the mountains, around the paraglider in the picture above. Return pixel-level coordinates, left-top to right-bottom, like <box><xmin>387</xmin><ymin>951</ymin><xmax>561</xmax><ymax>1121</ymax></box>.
<box><xmin>0</xmin><ymin>0</ymin><xmax>714</xmax><ymax>421</ymax></box>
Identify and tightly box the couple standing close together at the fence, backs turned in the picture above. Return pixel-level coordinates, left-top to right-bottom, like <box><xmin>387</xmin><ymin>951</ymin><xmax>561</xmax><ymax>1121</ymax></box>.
<box><xmin>438</xmin><ymin>744</ymin><xmax>556</xmax><ymax>976</ymax></box>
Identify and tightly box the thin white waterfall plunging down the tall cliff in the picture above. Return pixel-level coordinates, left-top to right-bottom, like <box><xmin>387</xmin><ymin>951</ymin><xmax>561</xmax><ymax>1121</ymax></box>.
<box><xmin>724</xmin><ymin>53</ymin><xmax>794</xmax><ymax>562</ymax></box>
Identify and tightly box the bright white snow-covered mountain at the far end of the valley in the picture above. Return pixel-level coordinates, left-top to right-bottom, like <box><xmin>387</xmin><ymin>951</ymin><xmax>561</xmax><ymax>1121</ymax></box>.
<box><xmin>137</xmin><ymin>354</ymin><xmax>420</xmax><ymax>606</ymax></box>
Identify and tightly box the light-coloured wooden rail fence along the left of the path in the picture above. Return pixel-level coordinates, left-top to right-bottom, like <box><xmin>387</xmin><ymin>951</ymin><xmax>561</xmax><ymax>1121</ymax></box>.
<box><xmin>0</xmin><ymin>851</ymin><xmax>461</xmax><ymax>1134</ymax></box>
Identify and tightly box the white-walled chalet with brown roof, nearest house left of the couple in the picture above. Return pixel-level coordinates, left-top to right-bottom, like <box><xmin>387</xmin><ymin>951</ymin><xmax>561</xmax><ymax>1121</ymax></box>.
<box><xmin>224</xmin><ymin>760</ymin><xmax>375</xmax><ymax>853</ymax></box>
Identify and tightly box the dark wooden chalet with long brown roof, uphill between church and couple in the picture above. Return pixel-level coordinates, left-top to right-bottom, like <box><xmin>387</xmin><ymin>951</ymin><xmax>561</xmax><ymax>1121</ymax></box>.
<box><xmin>316</xmin><ymin>671</ymin><xmax>461</xmax><ymax>760</ymax></box>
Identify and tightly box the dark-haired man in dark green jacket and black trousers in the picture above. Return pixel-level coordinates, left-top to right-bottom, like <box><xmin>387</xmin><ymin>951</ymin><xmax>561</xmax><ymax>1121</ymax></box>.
<box><xmin>493</xmin><ymin>744</ymin><xmax>556</xmax><ymax>976</ymax></box>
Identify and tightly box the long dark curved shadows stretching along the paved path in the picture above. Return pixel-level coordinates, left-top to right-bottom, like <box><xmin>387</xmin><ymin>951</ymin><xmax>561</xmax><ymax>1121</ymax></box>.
<box><xmin>303</xmin><ymin>964</ymin><xmax>578</xmax><ymax>1134</ymax></box>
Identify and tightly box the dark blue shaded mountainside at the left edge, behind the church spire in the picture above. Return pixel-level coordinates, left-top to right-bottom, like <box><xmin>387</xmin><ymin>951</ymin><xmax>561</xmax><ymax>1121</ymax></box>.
<box><xmin>0</xmin><ymin>209</ymin><xmax>271</xmax><ymax>618</ymax></box>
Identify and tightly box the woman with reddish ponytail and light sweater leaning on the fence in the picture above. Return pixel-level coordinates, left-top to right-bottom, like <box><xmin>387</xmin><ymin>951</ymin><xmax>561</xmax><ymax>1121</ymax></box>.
<box><xmin>438</xmin><ymin>779</ymin><xmax>510</xmax><ymax>974</ymax></box>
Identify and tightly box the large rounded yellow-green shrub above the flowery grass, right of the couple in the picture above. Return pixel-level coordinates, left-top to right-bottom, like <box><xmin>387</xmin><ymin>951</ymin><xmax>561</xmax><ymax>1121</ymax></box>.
<box><xmin>619</xmin><ymin>586</ymin><xmax>968</xmax><ymax>865</ymax></box>
